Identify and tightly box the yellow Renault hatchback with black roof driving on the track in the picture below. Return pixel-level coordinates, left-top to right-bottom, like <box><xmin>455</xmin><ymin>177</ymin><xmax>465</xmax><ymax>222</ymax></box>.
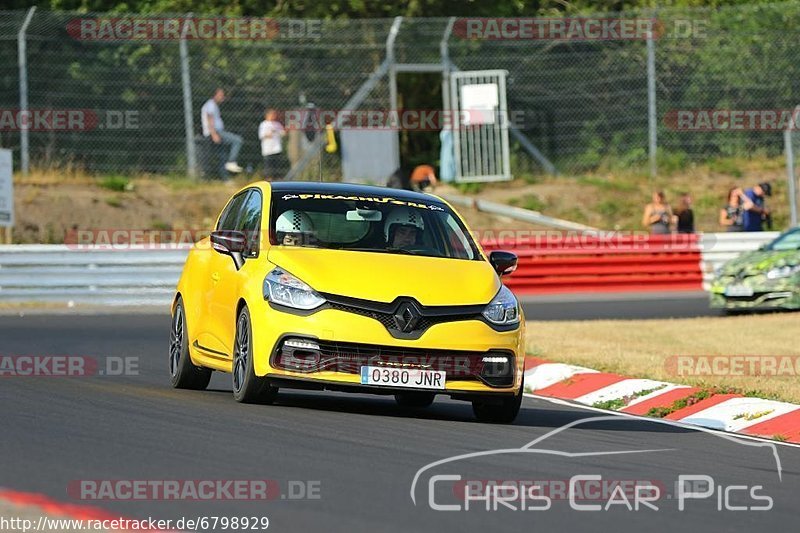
<box><xmin>169</xmin><ymin>182</ymin><xmax>525</xmax><ymax>423</ymax></box>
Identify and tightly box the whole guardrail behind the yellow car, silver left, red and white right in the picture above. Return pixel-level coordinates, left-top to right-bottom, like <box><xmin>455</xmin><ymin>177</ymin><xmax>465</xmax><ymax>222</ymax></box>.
<box><xmin>0</xmin><ymin>232</ymin><xmax>778</xmax><ymax>305</ymax></box>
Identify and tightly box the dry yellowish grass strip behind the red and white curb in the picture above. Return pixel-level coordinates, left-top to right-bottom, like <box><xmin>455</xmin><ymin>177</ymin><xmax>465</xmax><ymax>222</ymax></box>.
<box><xmin>527</xmin><ymin>313</ymin><xmax>800</xmax><ymax>404</ymax></box>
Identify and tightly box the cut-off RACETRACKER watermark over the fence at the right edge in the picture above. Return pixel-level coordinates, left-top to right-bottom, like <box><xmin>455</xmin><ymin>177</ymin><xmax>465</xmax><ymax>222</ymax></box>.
<box><xmin>664</xmin><ymin>108</ymin><xmax>800</xmax><ymax>131</ymax></box>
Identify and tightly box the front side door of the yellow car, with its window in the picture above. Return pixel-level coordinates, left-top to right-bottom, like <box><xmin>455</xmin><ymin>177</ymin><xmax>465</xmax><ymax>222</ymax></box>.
<box><xmin>209</xmin><ymin>189</ymin><xmax>263</xmax><ymax>355</ymax></box>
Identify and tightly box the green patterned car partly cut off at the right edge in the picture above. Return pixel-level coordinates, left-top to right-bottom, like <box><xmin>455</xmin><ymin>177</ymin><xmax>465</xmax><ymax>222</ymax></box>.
<box><xmin>711</xmin><ymin>227</ymin><xmax>800</xmax><ymax>311</ymax></box>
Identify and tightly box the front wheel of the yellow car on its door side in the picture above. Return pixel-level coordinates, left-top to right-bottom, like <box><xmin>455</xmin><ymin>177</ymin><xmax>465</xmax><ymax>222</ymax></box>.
<box><xmin>231</xmin><ymin>307</ymin><xmax>278</xmax><ymax>404</ymax></box>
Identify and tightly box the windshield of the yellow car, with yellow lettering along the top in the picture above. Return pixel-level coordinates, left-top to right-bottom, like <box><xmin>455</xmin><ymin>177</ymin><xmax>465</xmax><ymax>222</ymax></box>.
<box><xmin>270</xmin><ymin>190</ymin><xmax>480</xmax><ymax>260</ymax></box>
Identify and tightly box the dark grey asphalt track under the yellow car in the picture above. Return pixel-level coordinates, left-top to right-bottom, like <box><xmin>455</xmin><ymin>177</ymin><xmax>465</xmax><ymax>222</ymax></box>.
<box><xmin>0</xmin><ymin>314</ymin><xmax>800</xmax><ymax>533</ymax></box>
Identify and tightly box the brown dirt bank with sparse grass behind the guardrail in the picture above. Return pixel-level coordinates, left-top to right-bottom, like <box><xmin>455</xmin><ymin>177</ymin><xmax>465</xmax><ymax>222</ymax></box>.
<box><xmin>7</xmin><ymin>159</ymin><xmax>788</xmax><ymax>243</ymax></box>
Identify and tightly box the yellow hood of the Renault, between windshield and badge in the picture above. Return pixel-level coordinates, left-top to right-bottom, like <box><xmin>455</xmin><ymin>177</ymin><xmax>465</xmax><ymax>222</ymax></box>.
<box><xmin>268</xmin><ymin>247</ymin><xmax>501</xmax><ymax>305</ymax></box>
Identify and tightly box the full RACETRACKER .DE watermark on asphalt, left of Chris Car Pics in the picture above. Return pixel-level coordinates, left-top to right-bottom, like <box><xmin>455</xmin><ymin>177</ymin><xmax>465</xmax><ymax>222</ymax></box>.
<box><xmin>67</xmin><ymin>479</ymin><xmax>322</xmax><ymax>501</ymax></box>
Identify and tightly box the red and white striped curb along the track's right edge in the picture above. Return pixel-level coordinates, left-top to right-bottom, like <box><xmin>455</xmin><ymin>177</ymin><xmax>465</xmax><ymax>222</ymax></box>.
<box><xmin>524</xmin><ymin>357</ymin><xmax>800</xmax><ymax>443</ymax></box>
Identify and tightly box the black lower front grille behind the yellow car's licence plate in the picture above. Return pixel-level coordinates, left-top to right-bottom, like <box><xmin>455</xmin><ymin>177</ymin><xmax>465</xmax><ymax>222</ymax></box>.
<box><xmin>272</xmin><ymin>339</ymin><xmax>514</xmax><ymax>387</ymax></box>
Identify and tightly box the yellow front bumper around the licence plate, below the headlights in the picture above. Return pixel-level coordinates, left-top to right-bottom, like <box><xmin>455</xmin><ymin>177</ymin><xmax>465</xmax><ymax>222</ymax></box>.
<box><xmin>250</xmin><ymin>302</ymin><xmax>524</xmax><ymax>395</ymax></box>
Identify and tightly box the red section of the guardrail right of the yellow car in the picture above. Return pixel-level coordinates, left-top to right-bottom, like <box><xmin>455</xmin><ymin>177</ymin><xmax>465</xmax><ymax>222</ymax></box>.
<box><xmin>481</xmin><ymin>232</ymin><xmax>703</xmax><ymax>294</ymax></box>
